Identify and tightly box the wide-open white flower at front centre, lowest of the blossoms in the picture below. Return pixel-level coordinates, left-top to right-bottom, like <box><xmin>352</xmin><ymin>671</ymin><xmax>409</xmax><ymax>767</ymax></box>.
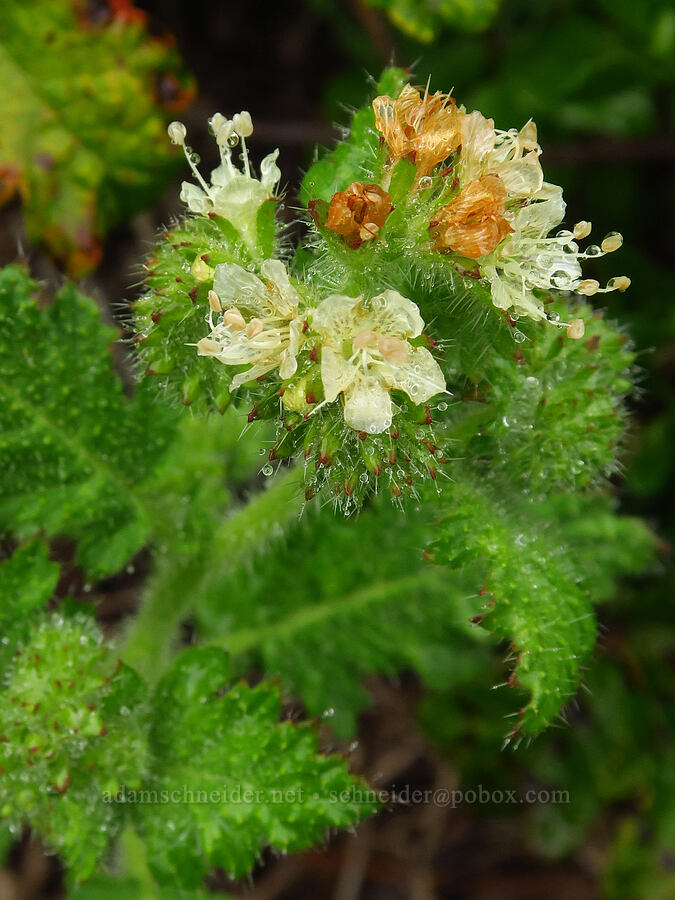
<box><xmin>312</xmin><ymin>290</ymin><xmax>445</xmax><ymax>434</ymax></box>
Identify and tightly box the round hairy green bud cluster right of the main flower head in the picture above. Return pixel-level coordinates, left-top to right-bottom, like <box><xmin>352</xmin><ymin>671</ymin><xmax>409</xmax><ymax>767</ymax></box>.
<box><xmin>448</xmin><ymin>298</ymin><xmax>635</xmax><ymax>492</ymax></box>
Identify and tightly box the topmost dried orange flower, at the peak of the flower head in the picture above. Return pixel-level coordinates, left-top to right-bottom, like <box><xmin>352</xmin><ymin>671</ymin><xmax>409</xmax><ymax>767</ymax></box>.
<box><xmin>373</xmin><ymin>84</ymin><xmax>461</xmax><ymax>177</ymax></box>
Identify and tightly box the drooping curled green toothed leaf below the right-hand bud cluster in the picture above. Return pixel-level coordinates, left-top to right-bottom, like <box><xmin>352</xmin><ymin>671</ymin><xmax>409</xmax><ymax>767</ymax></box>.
<box><xmin>432</xmin><ymin>470</ymin><xmax>654</xmax><ymax>739</ymax></box>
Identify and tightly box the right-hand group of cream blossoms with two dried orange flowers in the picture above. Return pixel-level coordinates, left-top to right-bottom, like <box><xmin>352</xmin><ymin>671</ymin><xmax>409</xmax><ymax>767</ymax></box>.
<box><xmin>373</xmin><ymin>85</ymin><xmax>630</xmax><ymax>337</ymax></box>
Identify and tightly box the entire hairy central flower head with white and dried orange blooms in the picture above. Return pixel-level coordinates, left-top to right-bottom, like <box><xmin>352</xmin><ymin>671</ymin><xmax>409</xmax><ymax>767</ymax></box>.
<box><xmin>144</xmin><ymin>87</ymin><xmax>630</xmax><ymax>509</ymax></box>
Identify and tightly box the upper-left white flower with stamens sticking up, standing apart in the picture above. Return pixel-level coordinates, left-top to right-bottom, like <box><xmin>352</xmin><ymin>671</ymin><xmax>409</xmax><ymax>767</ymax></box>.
<box><xmin>169</xmin><ymin>110</ymin><xmax>281</xmax><ymax>254</ymax></box>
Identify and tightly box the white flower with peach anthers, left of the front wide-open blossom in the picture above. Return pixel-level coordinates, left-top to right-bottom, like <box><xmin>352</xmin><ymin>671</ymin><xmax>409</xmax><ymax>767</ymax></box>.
<box><xmin>197</xmin><ymin>259</ymin><xmax>304</xmax><ymax>391</ymax></box>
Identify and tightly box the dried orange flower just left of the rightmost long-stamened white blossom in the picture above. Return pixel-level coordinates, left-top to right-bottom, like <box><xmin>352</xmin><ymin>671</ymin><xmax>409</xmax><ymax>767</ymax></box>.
<box><xmin>431</xmin><ymin>175</ymin><xmax>513</xmax><ymax>259</ymax></box>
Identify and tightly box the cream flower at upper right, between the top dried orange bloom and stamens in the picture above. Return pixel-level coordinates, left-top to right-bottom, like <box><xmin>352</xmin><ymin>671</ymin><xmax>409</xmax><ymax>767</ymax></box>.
<box><xmin>457</xmin><ymin>110</ymin><xmax>544</xmax><ymax>199</ymax></box>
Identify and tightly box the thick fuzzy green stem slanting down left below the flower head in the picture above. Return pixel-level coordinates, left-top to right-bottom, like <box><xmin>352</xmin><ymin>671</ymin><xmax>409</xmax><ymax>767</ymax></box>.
<box><xmin>122</xmin><ymin>471</ymin><xmax>304</xmax><ymax>682</ymax></box>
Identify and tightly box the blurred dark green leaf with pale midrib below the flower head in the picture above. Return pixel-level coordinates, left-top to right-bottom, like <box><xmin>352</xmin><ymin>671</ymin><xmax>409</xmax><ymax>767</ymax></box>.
<box><xmin>193</xmin><ymin>500</ymin><xmax>487</xmax><ymax>737</ymax></box>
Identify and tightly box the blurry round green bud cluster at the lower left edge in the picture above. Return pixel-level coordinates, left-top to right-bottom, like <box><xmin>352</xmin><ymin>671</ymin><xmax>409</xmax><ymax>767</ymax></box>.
<box><xmin>0</xmin><ymin>614</ymin><xmax>146</xmax><ymax>879</ymax></box>
